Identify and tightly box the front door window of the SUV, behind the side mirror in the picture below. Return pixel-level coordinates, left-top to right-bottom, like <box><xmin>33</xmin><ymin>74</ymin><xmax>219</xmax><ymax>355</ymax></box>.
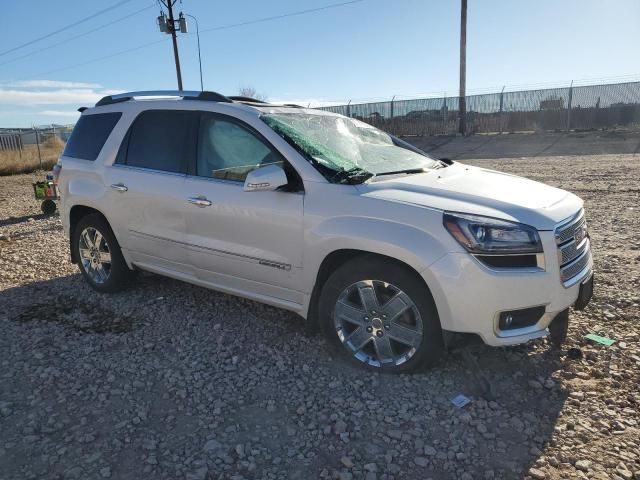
<box><xmin>196</xmin><ymin>114</ymin><xmax>283</xmax><ymax>182</ymax></box>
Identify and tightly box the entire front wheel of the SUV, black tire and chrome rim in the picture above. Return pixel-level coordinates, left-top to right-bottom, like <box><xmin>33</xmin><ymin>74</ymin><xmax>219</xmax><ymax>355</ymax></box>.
<box><xmin>318</xmin><ymin>256</ymin><xmax>444</xmax><ymax>373</ymax></box>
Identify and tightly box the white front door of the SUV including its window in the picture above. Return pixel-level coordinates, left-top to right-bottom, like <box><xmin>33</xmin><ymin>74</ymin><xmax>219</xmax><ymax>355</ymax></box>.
<box><xmin>185</xmin><ymin>113</ymin><xmax>304</xmax><ymax>304</ymax></box>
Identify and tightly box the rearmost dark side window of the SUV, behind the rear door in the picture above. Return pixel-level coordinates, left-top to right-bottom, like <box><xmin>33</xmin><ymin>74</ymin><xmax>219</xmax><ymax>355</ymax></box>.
<box><xmin>63</xmin><ymin>112</ymin><xmax>122</xmax><ymax>161</ymax></box>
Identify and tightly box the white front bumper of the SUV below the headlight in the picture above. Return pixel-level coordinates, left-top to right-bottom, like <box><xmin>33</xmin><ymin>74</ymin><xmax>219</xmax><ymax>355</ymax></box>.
<box><xmin>421</xmin><ymin>232</ymin><xmax>593</xmax><ymax>346</ymax></box>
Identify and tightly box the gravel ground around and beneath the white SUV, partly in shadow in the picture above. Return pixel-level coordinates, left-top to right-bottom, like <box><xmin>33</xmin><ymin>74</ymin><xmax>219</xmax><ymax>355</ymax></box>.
<box><xmin>0</xmin><ymin>155</ymin><xmax>640</xmax><ymax>480</ymax></box>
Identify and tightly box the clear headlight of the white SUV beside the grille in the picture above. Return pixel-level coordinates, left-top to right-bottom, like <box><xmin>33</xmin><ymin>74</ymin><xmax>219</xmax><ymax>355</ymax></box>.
<box><xmin>444</xmin><ymin>213</ymin><xmax>542</xmax><ymax>255</ymax></box>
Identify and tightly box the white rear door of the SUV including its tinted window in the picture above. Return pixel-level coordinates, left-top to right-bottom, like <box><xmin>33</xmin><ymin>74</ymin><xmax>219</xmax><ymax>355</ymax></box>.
<box><xmin>106</xmin><ymin>110</ymin><xmax>198</xmax><ymax>274</ymax></box>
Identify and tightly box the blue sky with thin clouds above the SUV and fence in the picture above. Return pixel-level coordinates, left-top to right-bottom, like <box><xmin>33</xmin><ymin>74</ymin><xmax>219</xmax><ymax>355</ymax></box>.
<box><xmin>0</xmin><ymin>0</ymin><xmax>640</xmax><ymax>127</ymax></box>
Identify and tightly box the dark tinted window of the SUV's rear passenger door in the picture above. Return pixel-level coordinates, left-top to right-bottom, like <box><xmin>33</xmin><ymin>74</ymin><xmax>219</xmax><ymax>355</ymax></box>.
<box><xmin>122</xmin><ymin>110</ymin><xmax>198</xmax><ymax>173</ymax></box>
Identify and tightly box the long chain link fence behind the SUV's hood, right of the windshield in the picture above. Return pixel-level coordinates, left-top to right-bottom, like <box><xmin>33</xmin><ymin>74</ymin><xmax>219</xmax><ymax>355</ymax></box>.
<box><xmin>322</xmin><ymin>82</ymin><xmax>640</xmax><ymax>136</ymax></box>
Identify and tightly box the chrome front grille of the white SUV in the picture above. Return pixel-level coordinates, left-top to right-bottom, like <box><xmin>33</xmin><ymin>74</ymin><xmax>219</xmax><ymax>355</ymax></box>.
<box><xmin>555</xmin><ymin>210</ymin><xmax>591</xmax><ymax>284</ymax></box>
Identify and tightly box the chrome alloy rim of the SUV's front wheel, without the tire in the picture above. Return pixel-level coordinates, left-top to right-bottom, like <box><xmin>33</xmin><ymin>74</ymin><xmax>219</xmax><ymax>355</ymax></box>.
<box><xmin>333</xmin><ymin>280</ymin><xmax>423</xmax><ymax>367</ymax></box>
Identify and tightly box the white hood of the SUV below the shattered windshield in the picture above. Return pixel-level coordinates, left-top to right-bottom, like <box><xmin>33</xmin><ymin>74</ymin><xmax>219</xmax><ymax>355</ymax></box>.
<box><xmin>358</xmin><ymin>162</ymin><xmax>582</xmax><ymax>230</ymax></box>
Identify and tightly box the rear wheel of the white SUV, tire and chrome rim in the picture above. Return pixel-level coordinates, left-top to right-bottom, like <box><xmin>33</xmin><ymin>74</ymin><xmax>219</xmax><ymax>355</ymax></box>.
<box><xmin>72</xmin><ymin>214</ymin><xmax>133</xmax><ymax>293</ymax></box>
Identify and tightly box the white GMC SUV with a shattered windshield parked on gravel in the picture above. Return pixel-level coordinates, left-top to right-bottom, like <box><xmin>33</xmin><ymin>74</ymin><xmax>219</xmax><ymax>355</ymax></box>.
<box><xmin>56</xmin><ymin>91</ymin><xmax>593</xmax><ymax>372</ymax></box>
